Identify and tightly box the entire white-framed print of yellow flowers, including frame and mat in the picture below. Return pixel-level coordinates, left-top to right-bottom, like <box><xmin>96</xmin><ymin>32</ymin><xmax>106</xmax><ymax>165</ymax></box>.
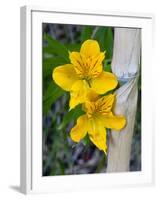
<box><xmin>21</xmin><ymin>6</ymin><xmax>154</xmax><ymax>193</ymax></box>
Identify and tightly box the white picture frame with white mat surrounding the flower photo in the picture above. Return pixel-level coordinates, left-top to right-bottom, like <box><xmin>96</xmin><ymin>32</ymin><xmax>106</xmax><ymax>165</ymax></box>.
<box><xmin>21</xmin><ymin>6</ymin><xmax>154</xmax><ymax>194</ymax></box>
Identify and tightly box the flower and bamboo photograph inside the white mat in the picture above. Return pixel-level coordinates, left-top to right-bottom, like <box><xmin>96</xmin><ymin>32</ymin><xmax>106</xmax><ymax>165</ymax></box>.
<box><xmin>42</xmin><ymin>23</ymin><xmax>142</xmax><ymax>176</ymax></box>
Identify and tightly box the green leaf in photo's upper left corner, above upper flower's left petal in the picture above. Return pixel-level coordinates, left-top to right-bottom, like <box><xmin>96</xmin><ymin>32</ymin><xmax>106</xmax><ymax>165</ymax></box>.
<box><xmin>43</xmin><ymin>34</ymin><xmax>69</xmax><ymax>62</ymax></box>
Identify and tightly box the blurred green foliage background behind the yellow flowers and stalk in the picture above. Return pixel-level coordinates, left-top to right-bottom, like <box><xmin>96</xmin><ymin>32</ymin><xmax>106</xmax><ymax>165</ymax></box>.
<box><xmin>42</xmin><ymin>24</ymin><xmax>141</xmax><ymax>176</ymax></box>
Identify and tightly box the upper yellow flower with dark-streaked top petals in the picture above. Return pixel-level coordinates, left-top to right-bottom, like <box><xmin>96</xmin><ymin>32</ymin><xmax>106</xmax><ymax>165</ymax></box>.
<box><xmin>52</xmin><ymin>40</ymin><xmax>118</xmax><ymax>109</ymax></box>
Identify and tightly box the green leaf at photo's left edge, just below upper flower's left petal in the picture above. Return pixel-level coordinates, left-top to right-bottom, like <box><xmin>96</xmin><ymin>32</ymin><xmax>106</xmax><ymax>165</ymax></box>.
<box><xmin>43</xmin><ymin>81</ymin><xmax>64</xmax><ymax>113</ymax></box>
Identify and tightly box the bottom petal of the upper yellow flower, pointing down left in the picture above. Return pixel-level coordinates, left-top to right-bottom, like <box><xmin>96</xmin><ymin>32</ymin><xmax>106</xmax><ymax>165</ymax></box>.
<box><xmin>69</xmin><ymin>80</ymin><xmax>89</xmax><ymax>109</ymax></box>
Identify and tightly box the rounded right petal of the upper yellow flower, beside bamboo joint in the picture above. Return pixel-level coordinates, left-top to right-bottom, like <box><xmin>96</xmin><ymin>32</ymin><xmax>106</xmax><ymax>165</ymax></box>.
<box><xmin>91</xmin><ymin>72</ymin><xmax>118</xmax><ymax>94</ymax></box>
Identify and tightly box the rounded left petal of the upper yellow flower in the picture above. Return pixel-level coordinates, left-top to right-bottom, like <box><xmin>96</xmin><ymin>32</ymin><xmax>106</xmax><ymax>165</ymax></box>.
<box><xmin>52</xmin><ymin>64</ymin><xmax>78</xmax><ymax>91</ymax></box>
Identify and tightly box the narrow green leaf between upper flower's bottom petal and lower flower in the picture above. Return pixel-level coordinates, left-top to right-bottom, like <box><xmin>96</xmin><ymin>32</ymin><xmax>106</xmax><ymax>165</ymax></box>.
<box><xmin>58</xmin><ymin>105</ymin><xmax>84</xmax><ymax>130</ymax></box>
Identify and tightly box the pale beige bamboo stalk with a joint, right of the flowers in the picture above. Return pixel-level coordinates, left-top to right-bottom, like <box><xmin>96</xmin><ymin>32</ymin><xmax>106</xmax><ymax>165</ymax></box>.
<box><xmin>107</xmin><ymin>28</ymin><xmax>141</xmax><ymax>172</ymax></box>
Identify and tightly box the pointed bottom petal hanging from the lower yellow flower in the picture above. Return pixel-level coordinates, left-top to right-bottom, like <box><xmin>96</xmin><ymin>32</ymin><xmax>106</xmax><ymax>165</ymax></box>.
<box><xmin>88</xmin><ymin>118</ymin><xmax>107</xmax><ymax>154</ymax></box>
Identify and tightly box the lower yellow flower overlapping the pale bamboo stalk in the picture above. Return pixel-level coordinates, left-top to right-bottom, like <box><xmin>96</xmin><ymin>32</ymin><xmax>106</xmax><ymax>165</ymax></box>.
<box><xmin>70</xmin><ymin>91</ymin><xmax>126</xmax><ymax>154</ymax></box>
